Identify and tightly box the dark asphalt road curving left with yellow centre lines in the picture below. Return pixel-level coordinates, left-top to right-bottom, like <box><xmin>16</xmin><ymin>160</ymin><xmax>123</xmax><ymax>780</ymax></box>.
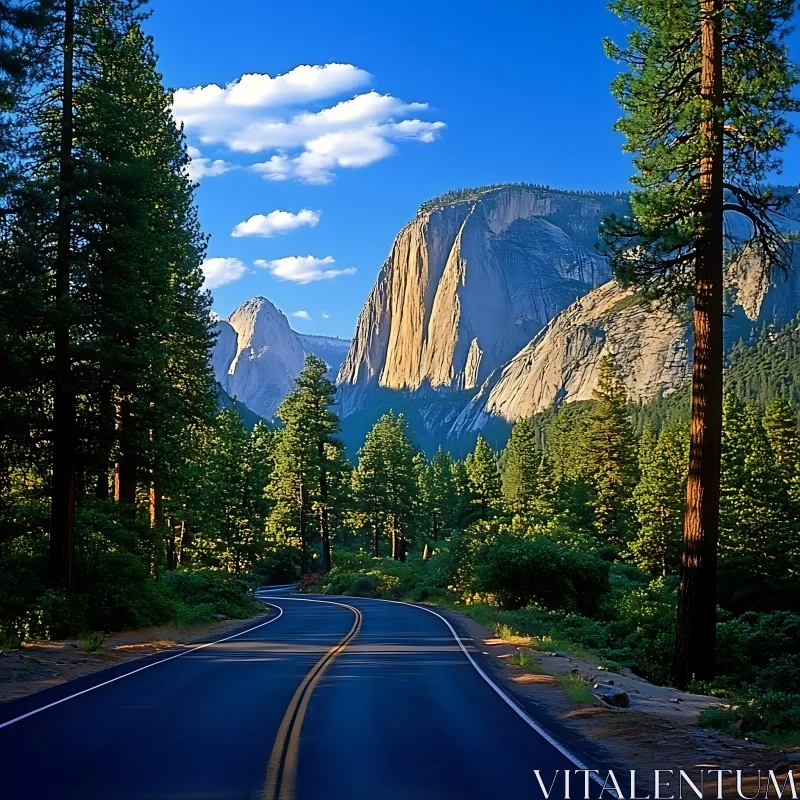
<box><xmin>0</xmin><ymin>593</ymin><xmax>599</xmax><ymax>800</ymax></box>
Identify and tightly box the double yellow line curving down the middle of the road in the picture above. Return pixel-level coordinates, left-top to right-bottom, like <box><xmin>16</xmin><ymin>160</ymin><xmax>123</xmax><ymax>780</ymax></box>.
<box><xmin>261</xmin><ymin>603</ymin><xmax>361</xmax><ymax>800</ymax></box>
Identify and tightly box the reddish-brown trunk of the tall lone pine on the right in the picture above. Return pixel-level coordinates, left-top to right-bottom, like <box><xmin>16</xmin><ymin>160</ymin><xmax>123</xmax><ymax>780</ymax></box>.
<box><xmin>675</xmin><ymin>0</ymin><xmax>723</xmax><ymax>688</ymax></box>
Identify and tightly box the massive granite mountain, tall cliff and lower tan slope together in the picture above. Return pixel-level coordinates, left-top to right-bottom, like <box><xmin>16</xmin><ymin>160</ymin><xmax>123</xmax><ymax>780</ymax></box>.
<box><xmin>338</xmin><ymin>184</ymin><xmax>800</xmax><ymax>453</ymax></box>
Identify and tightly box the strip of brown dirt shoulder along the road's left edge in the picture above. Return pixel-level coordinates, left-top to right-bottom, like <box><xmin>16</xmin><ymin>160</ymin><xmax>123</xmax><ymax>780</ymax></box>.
<box><xmin>0</xmin><ymin>614</ymin><xmax>263</xmax><ymax>704</ymax></box>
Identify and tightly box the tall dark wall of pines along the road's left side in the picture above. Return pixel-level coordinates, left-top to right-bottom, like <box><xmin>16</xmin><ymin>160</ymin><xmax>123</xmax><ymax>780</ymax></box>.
<box><xmin>0</xmin><ymin>0</ymin><xmax>256</xmax><ymax>638</ymax></box>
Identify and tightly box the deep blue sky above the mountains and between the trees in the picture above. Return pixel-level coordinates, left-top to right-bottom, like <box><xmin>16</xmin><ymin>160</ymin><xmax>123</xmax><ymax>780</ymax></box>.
<box><xmin>148</xmin><ymin>0</ymin><xmax>800</xmax><ymax>337</ymax></box>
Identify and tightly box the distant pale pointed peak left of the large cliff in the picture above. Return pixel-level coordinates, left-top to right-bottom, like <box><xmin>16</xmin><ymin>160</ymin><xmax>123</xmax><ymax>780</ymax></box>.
<box><xmin>212</xmin><ymin>297</ymin><xmax>350</xmax><ymax>420</ymax></box>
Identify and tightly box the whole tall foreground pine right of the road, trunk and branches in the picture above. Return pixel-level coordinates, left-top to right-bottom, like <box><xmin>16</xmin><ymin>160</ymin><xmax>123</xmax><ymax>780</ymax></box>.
<box><xmin>602</xmin><ymin>0</ymin><xmax>799</xmax><ymax>687</ymax></box>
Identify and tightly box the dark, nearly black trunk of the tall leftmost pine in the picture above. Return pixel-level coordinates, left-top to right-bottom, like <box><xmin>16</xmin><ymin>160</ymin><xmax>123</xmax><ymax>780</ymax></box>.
<box><xmin>50</xmin><ymin>0</ymin><xmax>77</xmax><ymax>592</ymax></box>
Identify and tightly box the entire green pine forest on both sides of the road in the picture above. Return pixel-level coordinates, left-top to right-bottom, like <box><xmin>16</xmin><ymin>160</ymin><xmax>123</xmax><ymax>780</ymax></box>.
<box><xmin>0</xmin><ymin>0</ymin><xmax>800</xmax><ymax>756</ymax></box>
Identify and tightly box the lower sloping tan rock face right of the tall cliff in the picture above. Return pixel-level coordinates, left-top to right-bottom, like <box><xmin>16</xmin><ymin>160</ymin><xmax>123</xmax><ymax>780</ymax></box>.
<box><xmin>451</xmin><ymin>281</ymin><xmax>691</xmax><ymax>435</ymax></box>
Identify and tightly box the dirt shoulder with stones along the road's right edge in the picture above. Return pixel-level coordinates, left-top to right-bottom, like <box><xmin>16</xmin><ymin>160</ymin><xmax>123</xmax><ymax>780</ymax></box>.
<box><xmin>444</xmin><ymin>611</ymin><xmax>797</xmax><ymax>784</ymax></box>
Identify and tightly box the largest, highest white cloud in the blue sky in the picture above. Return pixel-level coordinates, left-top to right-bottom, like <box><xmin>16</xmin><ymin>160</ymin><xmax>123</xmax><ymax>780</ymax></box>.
<box><xmin>173</xmin><ymin>64</ymin><xmax>445</xmax><ymax>183</ymax></box>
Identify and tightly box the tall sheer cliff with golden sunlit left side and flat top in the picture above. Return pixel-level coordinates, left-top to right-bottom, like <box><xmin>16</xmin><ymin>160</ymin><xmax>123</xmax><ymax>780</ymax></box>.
<box><xmin>339</xmin><ymin>186</ymin><xmax>626</xmax><ymax>417</ymax></box>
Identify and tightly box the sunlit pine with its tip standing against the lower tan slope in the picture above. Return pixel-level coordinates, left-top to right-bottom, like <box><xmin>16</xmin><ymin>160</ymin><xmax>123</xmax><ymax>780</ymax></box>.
<box><xmin>585</xmin><ymin>356</ymin><xmax>638</xmax><ymax>548</ymax></box>
